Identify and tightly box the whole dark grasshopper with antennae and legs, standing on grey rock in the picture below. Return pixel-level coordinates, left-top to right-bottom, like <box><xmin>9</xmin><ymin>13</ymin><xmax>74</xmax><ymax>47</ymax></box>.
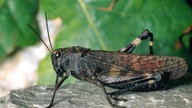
<box><xmin>29</xmin><ymin>14</ymin><xmax>187</xmax><ymax>108</ymax></box>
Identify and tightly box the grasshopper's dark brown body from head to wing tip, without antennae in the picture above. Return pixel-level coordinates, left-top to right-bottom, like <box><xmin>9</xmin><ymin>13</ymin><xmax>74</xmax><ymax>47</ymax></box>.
<box><xmin>52</xmin><ymin>46</ymin><xmax>187</xmax><ymax>91</ymax></box>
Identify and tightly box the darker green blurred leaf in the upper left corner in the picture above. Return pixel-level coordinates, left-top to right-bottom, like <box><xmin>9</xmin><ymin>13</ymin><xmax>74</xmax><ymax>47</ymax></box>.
<box><xmin>0</xmin><ymin>0</ymin><xmax>39</xmax><ymax>62</ymax></box>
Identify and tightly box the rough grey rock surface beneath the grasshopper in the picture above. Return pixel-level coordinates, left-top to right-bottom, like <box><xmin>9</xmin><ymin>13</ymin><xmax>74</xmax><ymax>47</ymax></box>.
<box><xmin>0</xmin><ymin>74</ymin><xmax>192</xmax><ymax>108</ymax></box>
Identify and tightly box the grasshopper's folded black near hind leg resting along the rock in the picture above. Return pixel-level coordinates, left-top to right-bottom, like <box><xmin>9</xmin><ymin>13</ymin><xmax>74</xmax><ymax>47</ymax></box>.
<box><xmin>108</xmin><ymin>73</ymin><xmax>169</xmax><ymax>101</ymax></box>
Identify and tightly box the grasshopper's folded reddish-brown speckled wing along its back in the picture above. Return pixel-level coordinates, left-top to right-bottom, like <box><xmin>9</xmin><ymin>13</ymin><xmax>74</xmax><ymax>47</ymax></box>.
<box><xmin>83</xmin><ymin>50</ymin><xmax>187</xmax><ymax>79</ymax></box>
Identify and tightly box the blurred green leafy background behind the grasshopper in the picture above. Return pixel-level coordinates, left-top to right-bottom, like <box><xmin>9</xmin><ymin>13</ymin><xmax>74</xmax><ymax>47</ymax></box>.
<box><xmin>0</xmin><ymin>0</ymin><xmax>192</xmax><ymax>84</ymax></box>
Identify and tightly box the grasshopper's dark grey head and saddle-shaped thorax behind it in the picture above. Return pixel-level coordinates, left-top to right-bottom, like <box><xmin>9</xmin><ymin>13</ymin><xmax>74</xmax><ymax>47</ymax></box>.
<box><xmin>51</xmin><ymin>46</ymin><xmax>89</xmax><ymax>76</ymax></box>
